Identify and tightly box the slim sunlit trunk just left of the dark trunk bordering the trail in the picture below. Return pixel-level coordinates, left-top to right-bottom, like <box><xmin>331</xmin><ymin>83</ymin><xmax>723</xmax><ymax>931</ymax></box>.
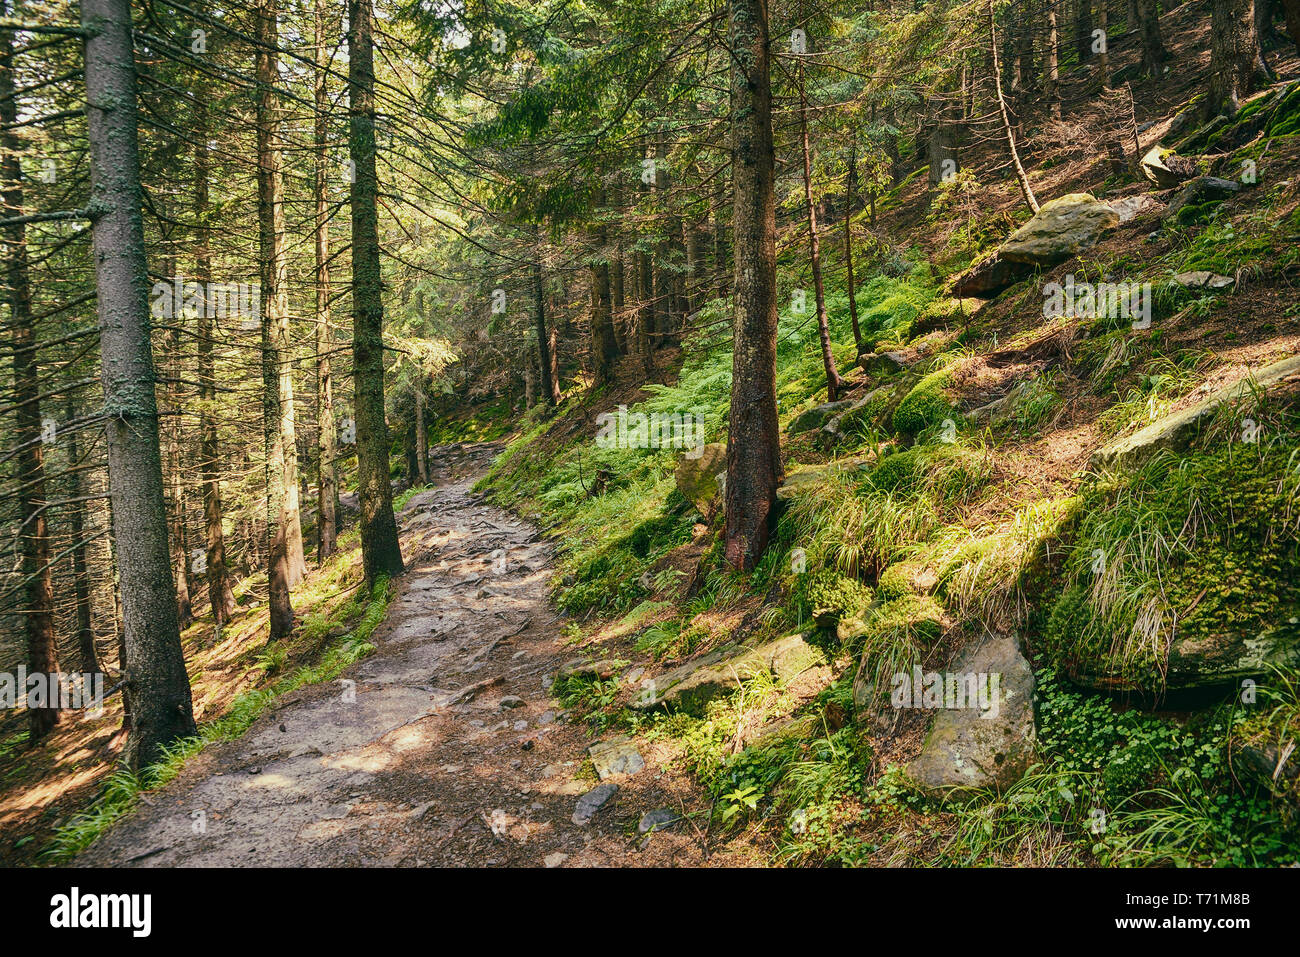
<box><xmin>312</xmin><ymin>0</ymin><xmax>338</xmax><ymax>564</ymax></box>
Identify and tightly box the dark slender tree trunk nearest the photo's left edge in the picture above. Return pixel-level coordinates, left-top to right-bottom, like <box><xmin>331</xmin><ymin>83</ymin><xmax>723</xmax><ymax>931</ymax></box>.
<box><xmin>0</xmin><ymin>30</ymin><xmax>59</xmax><ymax>742</ymax></box>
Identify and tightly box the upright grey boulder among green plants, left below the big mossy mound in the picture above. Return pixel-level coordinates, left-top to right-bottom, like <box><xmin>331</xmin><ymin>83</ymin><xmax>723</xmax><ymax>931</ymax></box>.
<box><xmin>900</xmin><ymin>635</ymin><xmax>1035</xmax><ymax>793</ymax></box>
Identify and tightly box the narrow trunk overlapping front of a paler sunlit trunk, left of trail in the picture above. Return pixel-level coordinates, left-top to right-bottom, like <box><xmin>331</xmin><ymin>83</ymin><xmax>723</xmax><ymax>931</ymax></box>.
<box><xmin>256</xmin><ymin>0</ymin><xmax>298</xmax><ymax>641</ymax></box>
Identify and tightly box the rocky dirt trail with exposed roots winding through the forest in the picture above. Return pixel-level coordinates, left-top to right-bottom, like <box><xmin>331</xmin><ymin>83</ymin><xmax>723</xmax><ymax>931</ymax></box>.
<box><xmin>78</xmin><ymin>443</ymin><xmax>736</xmax><ymax>866</ymax></box>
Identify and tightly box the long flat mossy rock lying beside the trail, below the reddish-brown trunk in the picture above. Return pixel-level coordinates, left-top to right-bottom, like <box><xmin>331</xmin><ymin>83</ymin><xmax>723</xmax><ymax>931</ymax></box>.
<box><xmin>631</xmin><ymin>635</ymin><xmax>826</xmax><ymax>714</ymax></box>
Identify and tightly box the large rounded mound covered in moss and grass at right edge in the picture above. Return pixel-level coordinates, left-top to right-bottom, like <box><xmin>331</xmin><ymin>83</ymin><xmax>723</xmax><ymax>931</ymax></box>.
<box><xmin>1044</xmin><ymin>434</ymin><xmax>1300</xmax><ymax>690</ymax></box>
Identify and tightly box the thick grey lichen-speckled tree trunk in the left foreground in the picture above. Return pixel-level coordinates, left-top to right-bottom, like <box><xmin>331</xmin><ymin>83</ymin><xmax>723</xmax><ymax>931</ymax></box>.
<box><xmin>81</xmin><ymin>0</ymin><xmax>195</xmax><ymax>768</ymax></box>
